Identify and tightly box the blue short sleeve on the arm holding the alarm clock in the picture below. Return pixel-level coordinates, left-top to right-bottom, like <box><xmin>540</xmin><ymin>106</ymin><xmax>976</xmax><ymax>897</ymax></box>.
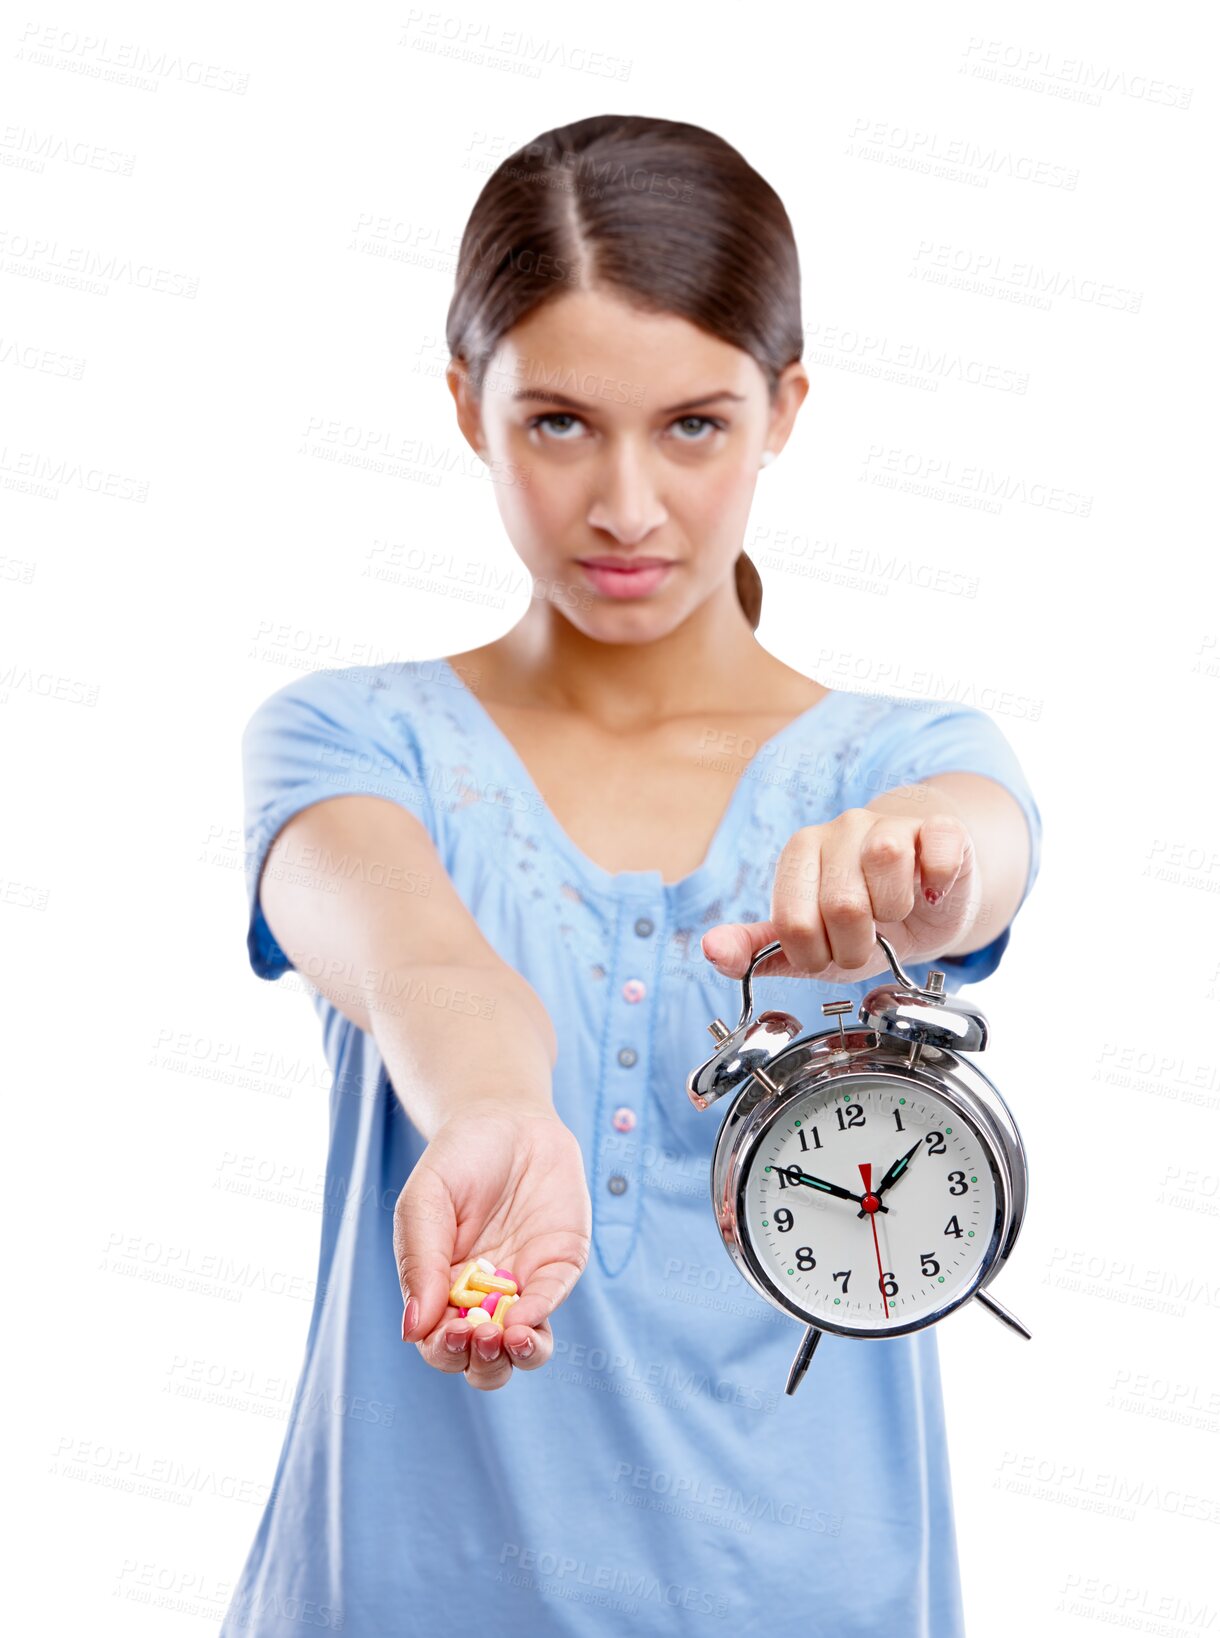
<box><xmin>843</xmin><ymin>701</ymin><xmax>1042</xmax><ymax>988</ymax></box>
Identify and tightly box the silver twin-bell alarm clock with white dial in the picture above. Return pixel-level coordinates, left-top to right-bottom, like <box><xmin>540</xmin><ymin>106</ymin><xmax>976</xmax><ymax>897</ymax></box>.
<box><xmin>686</xmin><ymin>934</ymin><xmax>1030</xmax><ymax>1394</ymax></box>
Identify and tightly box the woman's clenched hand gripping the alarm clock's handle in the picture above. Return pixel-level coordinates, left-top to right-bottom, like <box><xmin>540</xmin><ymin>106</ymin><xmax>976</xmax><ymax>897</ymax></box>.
<box><xmin>703</xmin><ymin>808</ymin><xmax>979</xmax><ymax>983</ymax></box>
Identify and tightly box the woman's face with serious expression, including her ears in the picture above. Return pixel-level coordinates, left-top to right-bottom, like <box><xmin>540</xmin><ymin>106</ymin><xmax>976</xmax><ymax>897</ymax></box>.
<box><xmin>450</xmin><ymin>290</ymin><xmax>809</xmax><ymax>642</ymax></box>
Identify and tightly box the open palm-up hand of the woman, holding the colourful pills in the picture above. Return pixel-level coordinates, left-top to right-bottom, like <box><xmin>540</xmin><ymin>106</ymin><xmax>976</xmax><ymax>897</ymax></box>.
<box><xmin>395</xmin><ymin>1099</ymin><xmax>593</xmax><ymax>1389</ymax></box>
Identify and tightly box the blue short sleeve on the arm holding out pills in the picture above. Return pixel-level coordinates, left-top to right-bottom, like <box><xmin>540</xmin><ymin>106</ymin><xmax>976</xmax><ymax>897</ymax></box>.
<box><xmin>241</xmin><ymin>667</ymin><xmax>439</xmax><ymax>978</ymax></box>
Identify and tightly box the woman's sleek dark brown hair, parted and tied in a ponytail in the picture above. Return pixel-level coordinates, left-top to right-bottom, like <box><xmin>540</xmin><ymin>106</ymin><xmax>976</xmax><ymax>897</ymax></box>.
<box><xmin>445</xmin><ymin>115</ymin><xmax>804</xmax><ymax>629</ymax></box>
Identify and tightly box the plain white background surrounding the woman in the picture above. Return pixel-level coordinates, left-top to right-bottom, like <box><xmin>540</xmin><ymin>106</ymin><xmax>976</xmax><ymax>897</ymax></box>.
<box><xmin>0</xmin><ymin>0</ymin><xmax>1220</xmax><ymax>1638</ymax></box>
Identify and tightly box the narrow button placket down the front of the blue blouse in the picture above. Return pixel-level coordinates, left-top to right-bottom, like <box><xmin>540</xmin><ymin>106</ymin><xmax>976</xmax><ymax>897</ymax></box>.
<box><xmin>593</xmin><ymin>903</ymin><xmax>663</xmax><ymax>1274</ymax></box>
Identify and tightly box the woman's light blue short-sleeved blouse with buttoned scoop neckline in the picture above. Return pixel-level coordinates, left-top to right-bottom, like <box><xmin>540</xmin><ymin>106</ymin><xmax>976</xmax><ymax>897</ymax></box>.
<box><xmin>223</xmin><ymin>660</ymin><xmax>1042</xmax><ymax>1638</ymax></box>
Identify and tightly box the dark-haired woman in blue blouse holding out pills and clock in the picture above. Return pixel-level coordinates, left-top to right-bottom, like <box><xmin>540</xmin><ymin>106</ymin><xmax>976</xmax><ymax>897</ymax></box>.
<box><xmin>224</xmin><ymin>116</ymin><xmax>1040</xmax><ymax>1638</ymax></box>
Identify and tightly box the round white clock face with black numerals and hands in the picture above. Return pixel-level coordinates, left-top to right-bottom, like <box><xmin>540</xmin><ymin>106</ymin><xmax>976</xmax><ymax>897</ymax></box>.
<box><xmin>740</xmin><ymin>1075</ymin><xmax>997</xmax><ymax>1333</ymax></box>
